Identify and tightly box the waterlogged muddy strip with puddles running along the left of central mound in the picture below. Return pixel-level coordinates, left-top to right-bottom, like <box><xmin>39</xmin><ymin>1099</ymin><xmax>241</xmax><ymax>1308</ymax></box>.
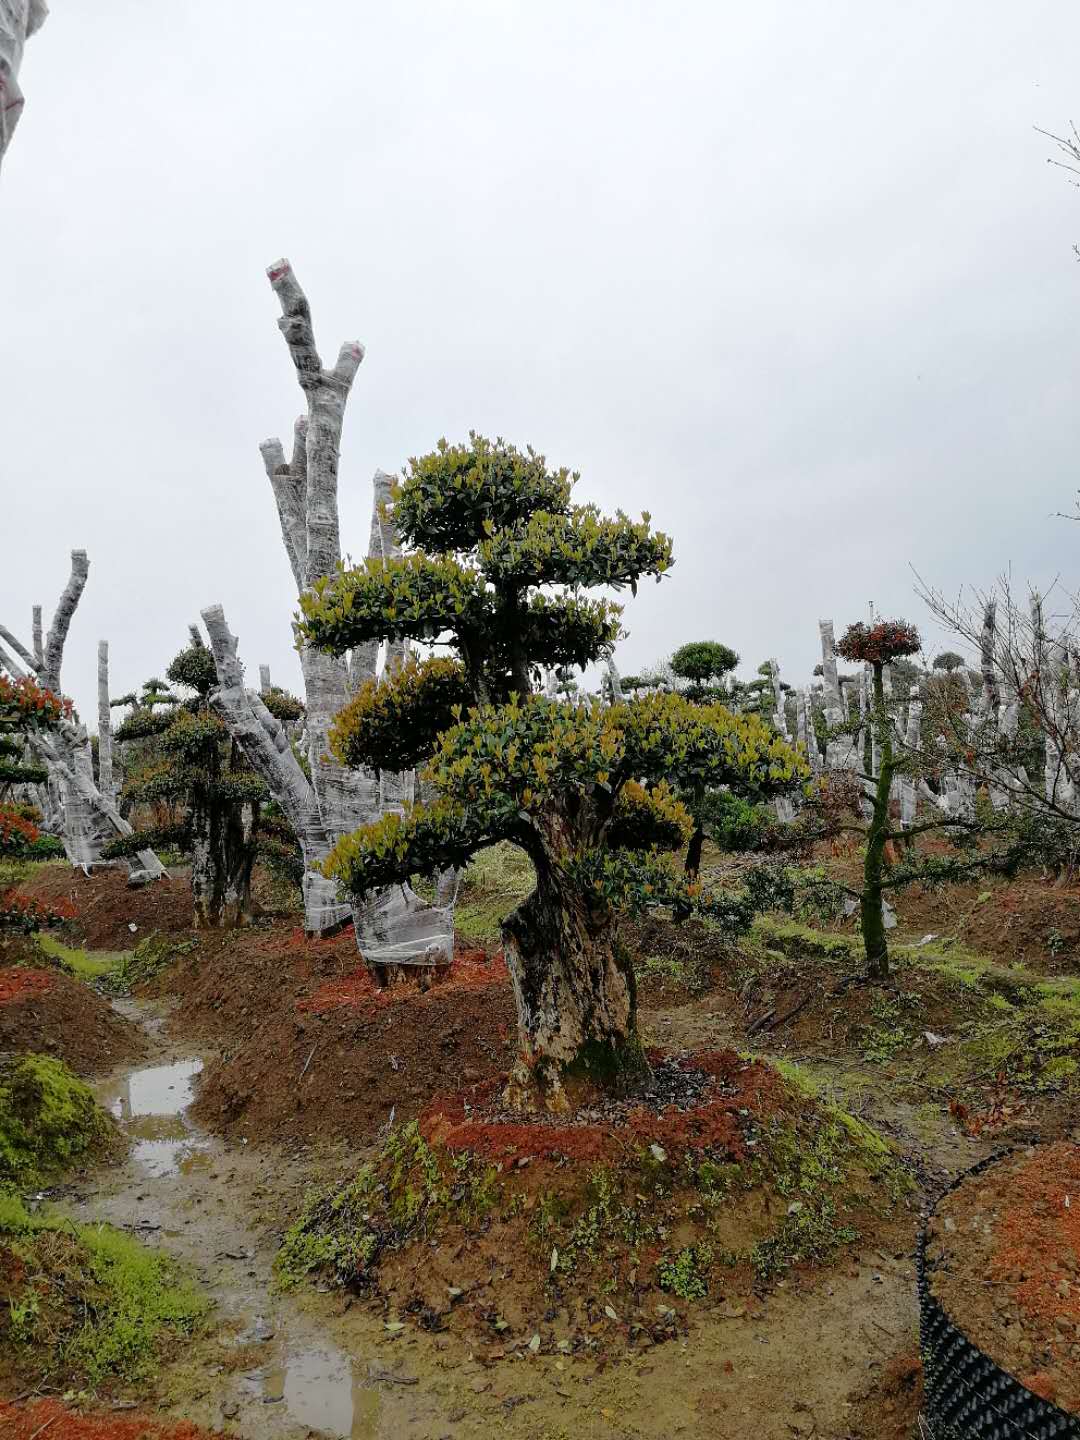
<box><xmin>73</xmin><ymin>1001</ymin><xmax>448</xmax><ymax>1440</ymax></box>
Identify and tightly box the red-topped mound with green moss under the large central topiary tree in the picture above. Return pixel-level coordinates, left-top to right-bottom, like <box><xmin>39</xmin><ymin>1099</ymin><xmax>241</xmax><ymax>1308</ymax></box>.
<box><xmin>278</xmin><ymin>1051</ymin><xmax>909</xmax><ymax>1351</ymax></box>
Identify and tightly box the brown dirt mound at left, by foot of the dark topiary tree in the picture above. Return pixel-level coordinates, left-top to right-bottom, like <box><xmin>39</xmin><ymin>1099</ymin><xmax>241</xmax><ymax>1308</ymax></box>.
<box><xmin>19</xmin><ymin>864</ymin><xmax>193</xmax><ymax>950</ymax></box>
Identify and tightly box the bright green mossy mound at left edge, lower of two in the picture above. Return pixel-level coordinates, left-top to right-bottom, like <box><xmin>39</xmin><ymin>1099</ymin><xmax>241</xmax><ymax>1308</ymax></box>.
<box><xmin>0</xmin><ymin>1187</ymin><xmax>207</xmax><ymax>1390</ymax></box>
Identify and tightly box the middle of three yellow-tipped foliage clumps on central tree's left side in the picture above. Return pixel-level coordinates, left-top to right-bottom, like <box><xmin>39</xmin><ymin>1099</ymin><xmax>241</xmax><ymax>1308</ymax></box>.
<box><xmin>330</xmin><ymin>658</ymin><xmax>471</xmax><ymax>770</ymax></box>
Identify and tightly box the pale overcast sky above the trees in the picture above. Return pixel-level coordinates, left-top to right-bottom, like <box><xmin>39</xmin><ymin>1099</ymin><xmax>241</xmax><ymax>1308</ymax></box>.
<box><xmin>0</xmin><ymin>0</ymin><xmax>1080</xmax><ymax>724</ymax></box>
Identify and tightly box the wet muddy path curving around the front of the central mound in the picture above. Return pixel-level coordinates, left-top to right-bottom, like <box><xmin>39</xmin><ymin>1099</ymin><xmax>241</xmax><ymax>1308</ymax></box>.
<box><xmin>48</xmin><ymin>1001</ymin><xmax>969</xmax><ymax>1440</ymax></box>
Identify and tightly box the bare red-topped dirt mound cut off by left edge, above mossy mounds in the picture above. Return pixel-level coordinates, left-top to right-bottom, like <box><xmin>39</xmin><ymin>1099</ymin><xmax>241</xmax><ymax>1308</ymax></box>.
<box><xmin>0</xmin><ymin>965</ymin><xmax>145</xmax><ymax>1076</ymax></box>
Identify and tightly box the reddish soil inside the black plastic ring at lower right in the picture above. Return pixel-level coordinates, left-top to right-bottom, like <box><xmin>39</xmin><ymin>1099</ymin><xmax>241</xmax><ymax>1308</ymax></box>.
<box><xmin>926</xmin><ymin>1140</ymin><xmax>1080</xmax><ymax>1414</ymax></box>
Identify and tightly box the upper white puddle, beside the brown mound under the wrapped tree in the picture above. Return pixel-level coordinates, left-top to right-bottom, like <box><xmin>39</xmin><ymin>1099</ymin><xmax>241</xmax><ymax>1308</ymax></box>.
<box><xmin>98</xmin><ymin>1060</ymin><xmax>209</xmax><ymax>1176</ymax></box>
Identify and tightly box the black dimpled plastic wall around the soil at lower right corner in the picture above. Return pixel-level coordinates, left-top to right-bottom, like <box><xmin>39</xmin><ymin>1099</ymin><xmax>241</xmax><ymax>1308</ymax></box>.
<box><xmin>917</xmin><ymin>1152</ymin><xmax>1080</xmax><ymax>1440</ymax></box>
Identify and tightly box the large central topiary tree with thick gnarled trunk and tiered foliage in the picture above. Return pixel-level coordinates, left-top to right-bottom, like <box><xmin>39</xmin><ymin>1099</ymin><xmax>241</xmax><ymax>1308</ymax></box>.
<box><xmin>300</xmin><ymin>435</ymin><xmax>804</xmax><ymax>1110</ymax></box>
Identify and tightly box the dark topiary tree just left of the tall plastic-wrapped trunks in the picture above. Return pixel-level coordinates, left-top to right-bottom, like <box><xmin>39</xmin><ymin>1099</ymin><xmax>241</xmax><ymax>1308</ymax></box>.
<box><xmin>107</xmin><ymin>626</ymin><xmax>295</xmax><ymax>926</ymax></box>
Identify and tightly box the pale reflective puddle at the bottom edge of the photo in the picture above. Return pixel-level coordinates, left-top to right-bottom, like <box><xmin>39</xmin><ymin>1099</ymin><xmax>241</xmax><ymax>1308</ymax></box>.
<box><xmin>256</xmin><ymin>1345</ymin><xmax>380</xmax><ymax>1440</ymax></box>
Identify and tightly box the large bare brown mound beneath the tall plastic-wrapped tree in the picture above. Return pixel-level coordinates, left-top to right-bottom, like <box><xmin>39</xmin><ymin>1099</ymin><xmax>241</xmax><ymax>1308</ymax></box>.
<box><xmin>187</xmin><ymin>927</ymin><xmax>516</xmax><ymax>1143</ymax></box>
